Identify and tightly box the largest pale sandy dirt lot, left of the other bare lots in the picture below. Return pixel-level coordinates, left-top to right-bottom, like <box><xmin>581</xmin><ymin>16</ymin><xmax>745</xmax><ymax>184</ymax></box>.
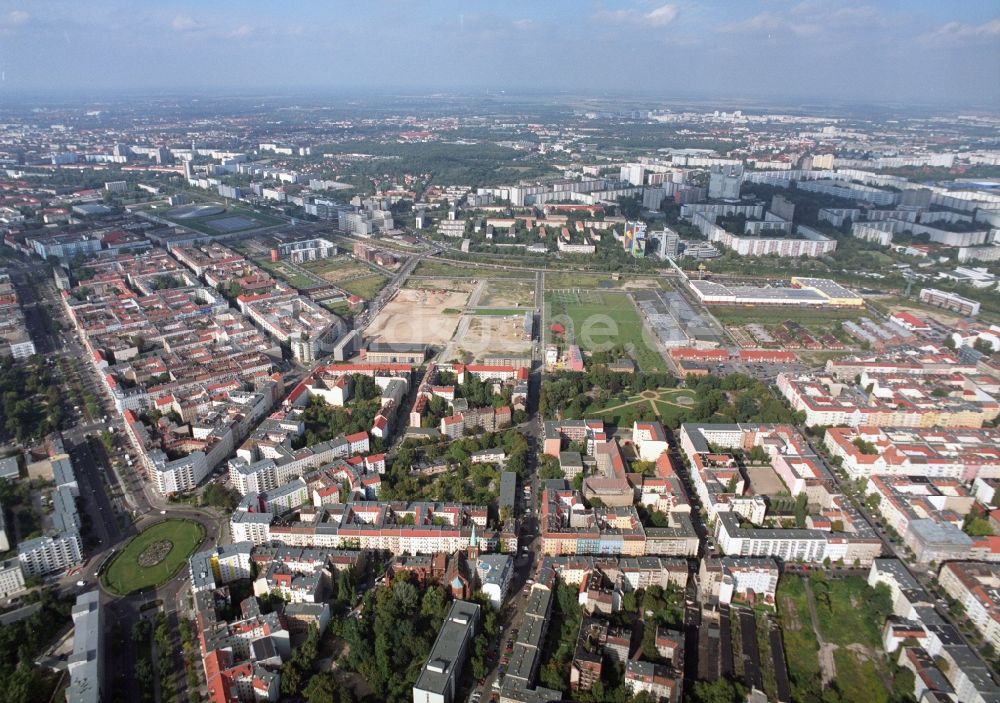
<box><xmin>366</xmin><ymin>287</ymin><xmax>469</xmax><ymax>345</ymax></box>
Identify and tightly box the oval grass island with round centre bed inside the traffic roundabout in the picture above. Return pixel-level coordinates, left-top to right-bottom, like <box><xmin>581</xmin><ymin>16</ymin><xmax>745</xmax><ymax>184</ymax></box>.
<box><xmin>101</xmin><ymin>519</ymin><xmax>205</xmax><ymax>596</ymax></box>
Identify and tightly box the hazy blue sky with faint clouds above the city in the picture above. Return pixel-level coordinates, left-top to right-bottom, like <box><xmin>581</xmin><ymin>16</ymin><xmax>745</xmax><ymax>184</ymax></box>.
<box><xmin>0</xmin><ymin>0</ymin><xmax>1000</xmax><ymax>109</ymax></box>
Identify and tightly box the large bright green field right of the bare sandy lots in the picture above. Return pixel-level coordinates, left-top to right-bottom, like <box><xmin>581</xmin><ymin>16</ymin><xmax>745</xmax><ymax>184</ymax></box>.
<box><xmin>545</xmin><ymin>290</ymin><xmax>666</xmax><ymax>372</ymax></box>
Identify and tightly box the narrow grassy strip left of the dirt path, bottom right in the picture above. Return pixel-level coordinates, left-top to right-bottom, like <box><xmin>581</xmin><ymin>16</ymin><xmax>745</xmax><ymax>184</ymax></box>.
<box><xmin>777</xmin><ymin>576</ymin><xmax>820</xmax><ymax>701</ymax></box>
